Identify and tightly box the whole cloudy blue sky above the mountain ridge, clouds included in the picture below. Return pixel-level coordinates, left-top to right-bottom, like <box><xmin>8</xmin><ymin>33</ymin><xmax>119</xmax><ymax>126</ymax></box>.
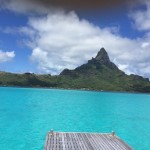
<box><xmin>0</xmin><ymin>0</ymin><xmax>150</xmax><ymax>78</ymax></box>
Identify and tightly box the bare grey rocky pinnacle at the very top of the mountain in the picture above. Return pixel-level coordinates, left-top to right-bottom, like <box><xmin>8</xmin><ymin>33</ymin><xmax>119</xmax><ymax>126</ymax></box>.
<box><xmin>95</xmin><ymin>48</ymin><xmax>110</xmax><ymax>63</ymax></box>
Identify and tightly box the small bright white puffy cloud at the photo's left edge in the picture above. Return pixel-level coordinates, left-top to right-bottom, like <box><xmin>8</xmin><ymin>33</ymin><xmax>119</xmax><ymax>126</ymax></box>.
<box><xmin>0</xmin><ymin>50</ymin><xmax>15</xmax><ymax>63</ymax></box>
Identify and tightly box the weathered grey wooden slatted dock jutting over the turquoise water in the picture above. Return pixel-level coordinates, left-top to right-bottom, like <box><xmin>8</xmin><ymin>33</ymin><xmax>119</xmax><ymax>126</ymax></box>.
<box><xmin>44</xmin><ymin>131</ymin><xmax>133</xmax><ymax>150</ymax></box>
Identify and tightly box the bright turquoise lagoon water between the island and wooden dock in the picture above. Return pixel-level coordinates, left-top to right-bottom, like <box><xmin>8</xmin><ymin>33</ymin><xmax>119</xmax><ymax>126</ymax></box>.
<box><xmin>0</xmin><ymin>87</ymin><xmax>150</xmax><ymax>150</ymax></box>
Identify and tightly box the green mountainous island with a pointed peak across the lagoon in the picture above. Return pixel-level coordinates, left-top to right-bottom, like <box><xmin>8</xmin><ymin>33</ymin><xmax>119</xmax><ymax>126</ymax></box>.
<box><xmin>0</xmin><ymin>48</ymin><xmax>150</xmax><ymax>93</ymax></box>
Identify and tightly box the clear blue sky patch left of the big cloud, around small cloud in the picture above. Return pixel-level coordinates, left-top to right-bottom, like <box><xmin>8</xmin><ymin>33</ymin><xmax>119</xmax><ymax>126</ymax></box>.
<box><xmin>0</xmin><ymin>10</ymin><xmax>35</xmax><ymax>73</ymax></box>
